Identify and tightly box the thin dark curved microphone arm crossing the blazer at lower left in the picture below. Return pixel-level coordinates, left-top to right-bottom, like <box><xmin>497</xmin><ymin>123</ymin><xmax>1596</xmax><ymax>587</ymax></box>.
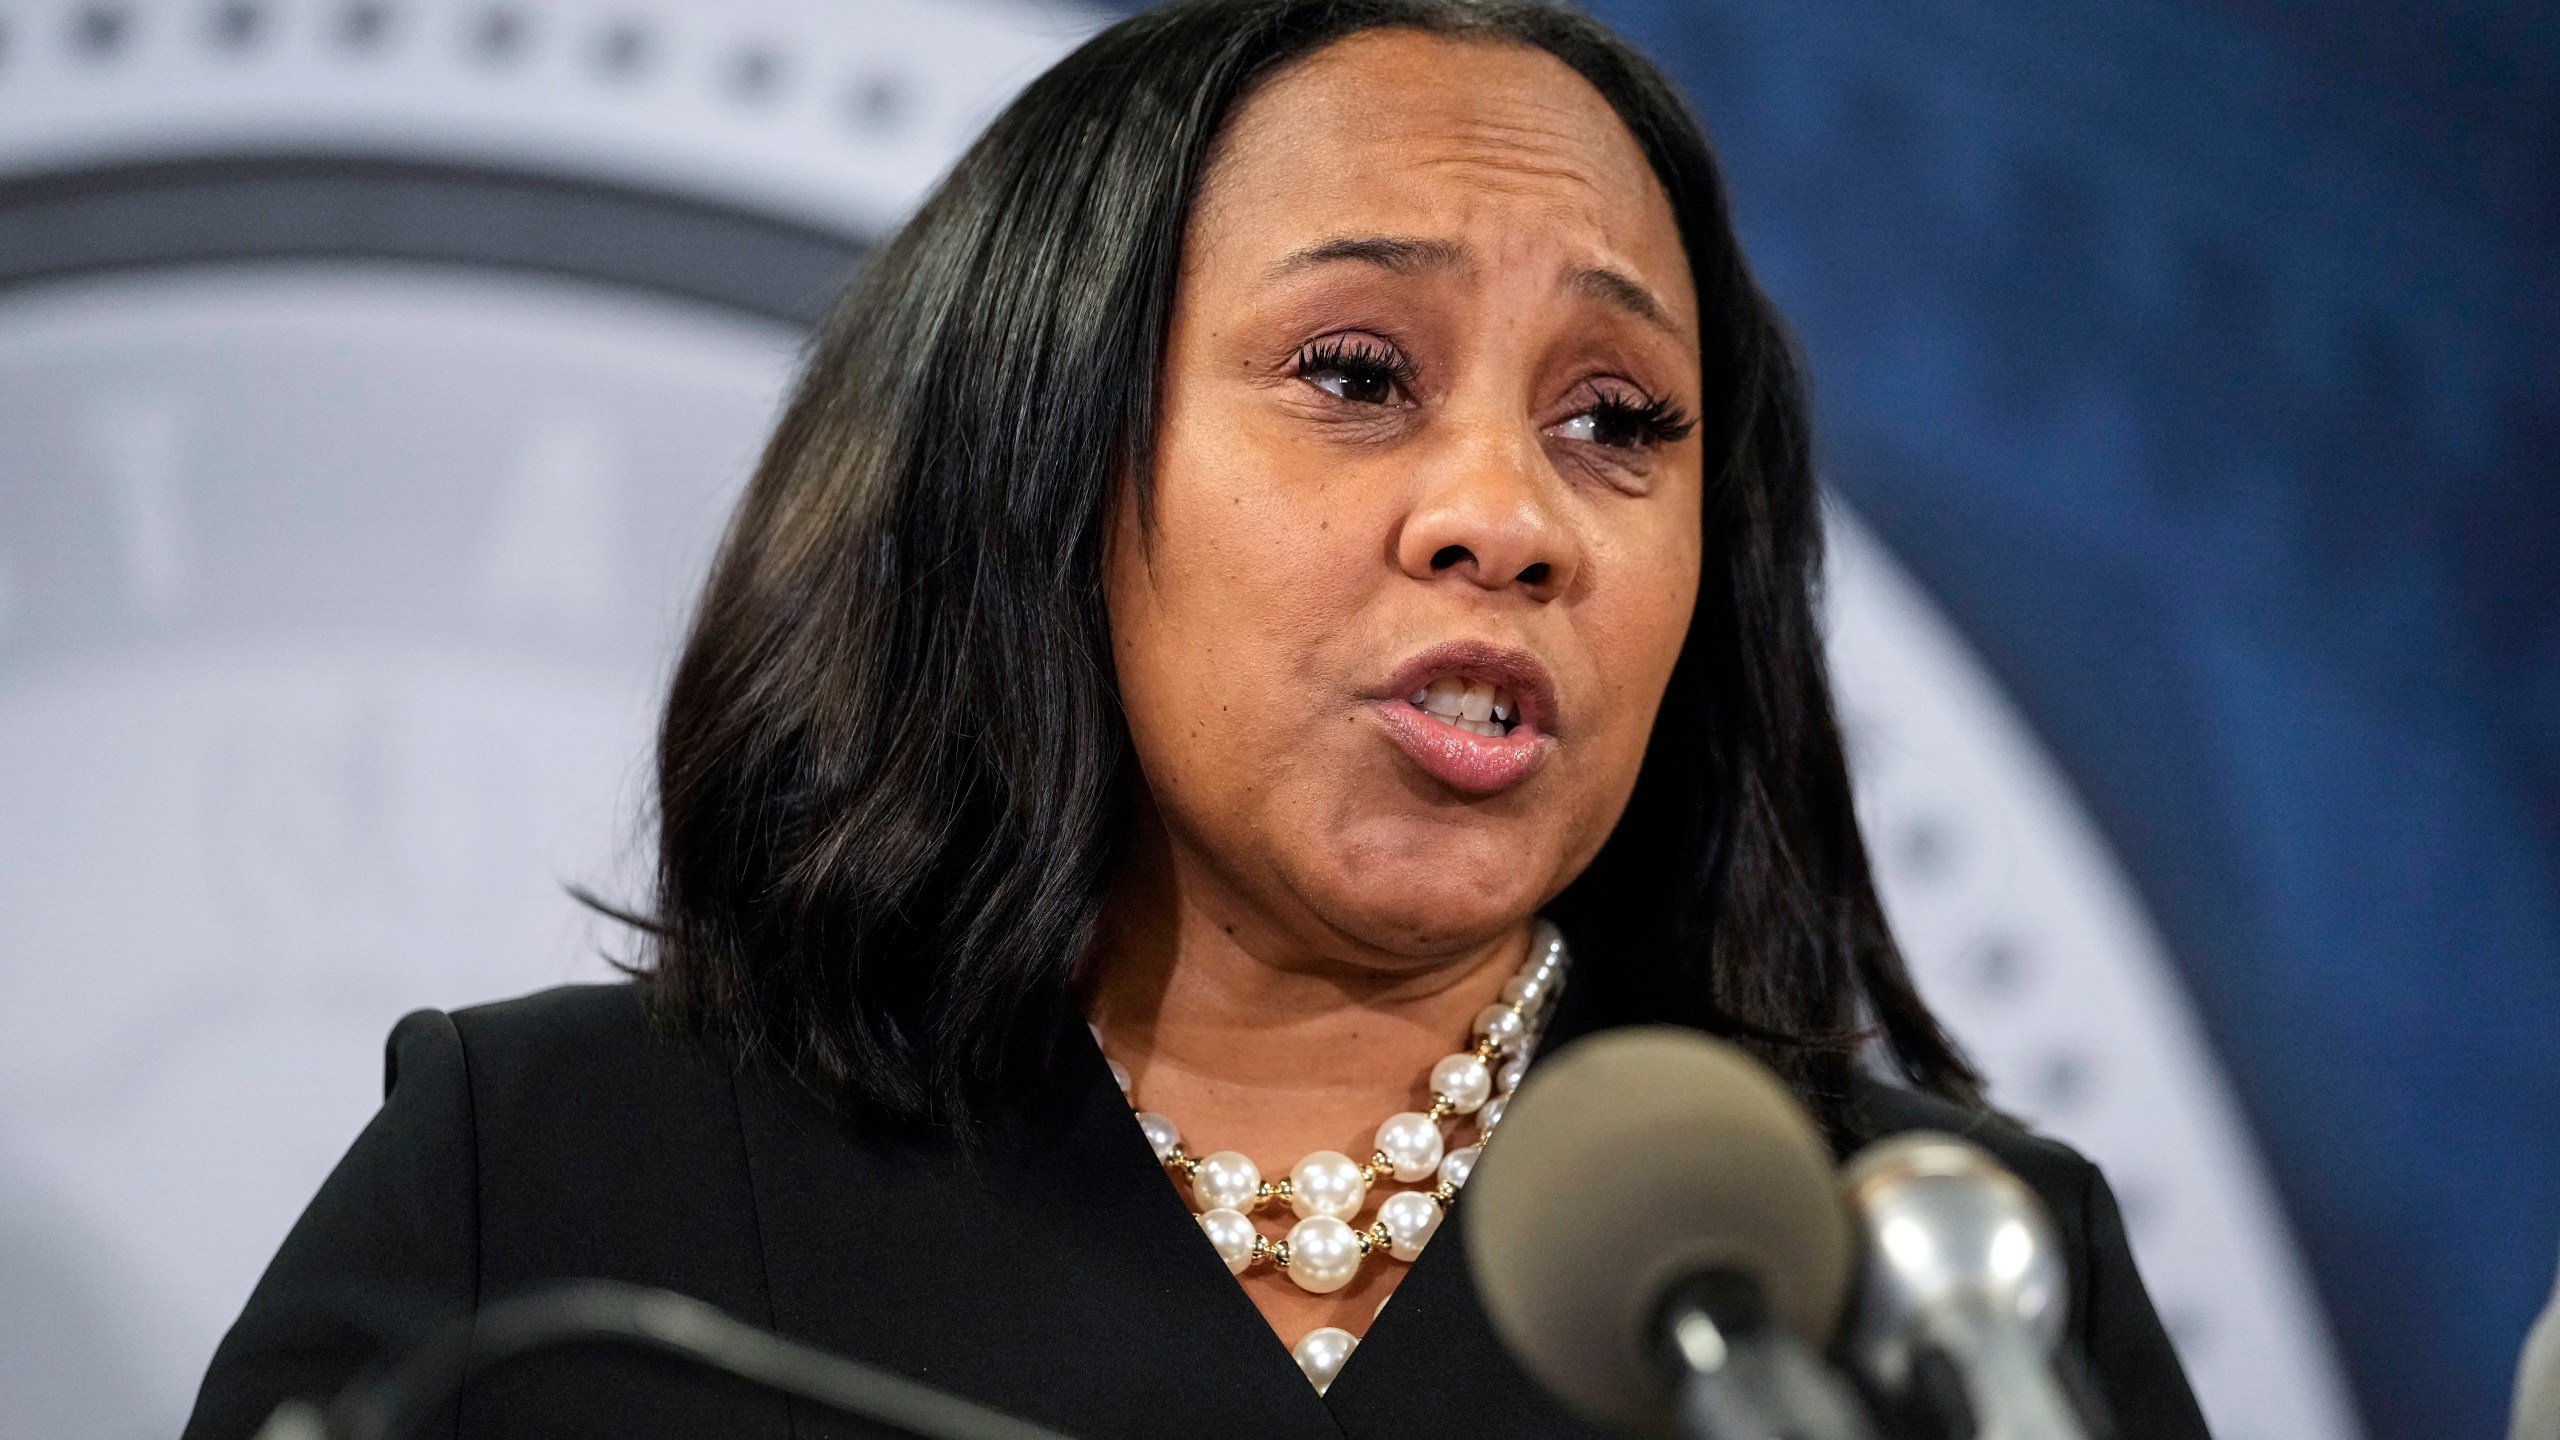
<box><xmin>256</xmin><ymin>1281</ymin><xmax>1068</xmax><ymax>1440</ymax></box>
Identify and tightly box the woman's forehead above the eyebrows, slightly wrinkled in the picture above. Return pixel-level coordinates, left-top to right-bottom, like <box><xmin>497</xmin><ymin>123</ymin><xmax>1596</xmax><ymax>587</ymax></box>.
<box><xmin>1190</xmin><ymin>31</ymin><xmax>1695</xmax><ymax>333</ymax></box>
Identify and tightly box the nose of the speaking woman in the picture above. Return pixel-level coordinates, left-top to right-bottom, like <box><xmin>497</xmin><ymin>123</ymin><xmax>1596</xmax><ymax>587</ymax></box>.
<box><xmin>1395</xmin><ymin>422</ymin><xmax>1582</xmax><ymax>600</ymax></box>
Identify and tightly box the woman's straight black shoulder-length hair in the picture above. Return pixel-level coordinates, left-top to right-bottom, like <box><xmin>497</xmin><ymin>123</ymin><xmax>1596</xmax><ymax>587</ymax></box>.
<box><xmin>643</xmin><ymin>0</ymin><xmax>1976</xmax><ymax>1127</ymax></box>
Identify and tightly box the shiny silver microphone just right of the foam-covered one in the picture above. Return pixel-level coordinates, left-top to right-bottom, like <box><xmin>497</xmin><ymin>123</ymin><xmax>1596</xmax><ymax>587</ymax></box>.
<box><xmin>1846</xmin><ymin>1130</ymin><xmax>2086</xmax><ymax>1440</ymax></box>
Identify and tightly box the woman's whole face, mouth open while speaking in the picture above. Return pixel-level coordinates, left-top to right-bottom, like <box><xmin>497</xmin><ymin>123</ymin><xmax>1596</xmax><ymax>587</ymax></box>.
<box><xmin>1106</xmin><ymin>31</ymin><xmax>1702</xmax><ymax>963</ymax></box>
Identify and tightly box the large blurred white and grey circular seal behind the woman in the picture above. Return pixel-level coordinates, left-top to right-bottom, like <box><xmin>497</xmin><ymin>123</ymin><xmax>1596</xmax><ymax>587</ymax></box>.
<box><xmin>0</xmin><ymin>0</ymin><xmax>2353</xmax><ymax>1440</ymax></box>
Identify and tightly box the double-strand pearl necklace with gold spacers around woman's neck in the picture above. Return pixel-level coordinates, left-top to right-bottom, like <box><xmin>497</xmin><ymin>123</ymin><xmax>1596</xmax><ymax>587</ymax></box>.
<box><xmin>1093</xmin><ymin>920</ymin><xmax>1569</xmax><ymax>1394</ymax></box>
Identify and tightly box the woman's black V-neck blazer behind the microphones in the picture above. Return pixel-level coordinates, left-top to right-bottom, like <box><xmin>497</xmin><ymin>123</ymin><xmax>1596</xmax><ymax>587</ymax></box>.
<box><xmin>187</xmin><ymin>986</ymin><xmax>2204</xmax><ymax>1440</ymax></box>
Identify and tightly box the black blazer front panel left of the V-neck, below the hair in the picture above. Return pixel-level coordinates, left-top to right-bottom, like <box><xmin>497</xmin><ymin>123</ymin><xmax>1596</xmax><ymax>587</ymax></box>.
<box><xmin>737</xmin><ymin>1025</ymin><xmax>1341</xmax><ymax>1440</ymax></box>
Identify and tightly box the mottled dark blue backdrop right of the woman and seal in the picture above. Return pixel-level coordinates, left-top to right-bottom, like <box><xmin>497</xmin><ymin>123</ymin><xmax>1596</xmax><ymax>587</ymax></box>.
<box><xmin>1566</xmin><ymin>0</ymin><xmax>2560</xmax><ymax>1440</ymax></box>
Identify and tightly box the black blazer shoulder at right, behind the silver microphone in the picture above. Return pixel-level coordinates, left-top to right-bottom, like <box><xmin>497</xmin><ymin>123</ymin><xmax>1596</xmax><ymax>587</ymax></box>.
<box><xmin>1851</xmin><ymin>1079</ymin><xmax>2207</xmax><ymax>1440</ymax></box>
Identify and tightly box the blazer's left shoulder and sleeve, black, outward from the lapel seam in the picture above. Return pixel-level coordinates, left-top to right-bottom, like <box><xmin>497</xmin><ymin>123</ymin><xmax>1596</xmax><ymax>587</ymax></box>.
<box><xmin>187</xmin><ymin>984</ymin><xmax>786</xmax><ymax>1440</ymax></box>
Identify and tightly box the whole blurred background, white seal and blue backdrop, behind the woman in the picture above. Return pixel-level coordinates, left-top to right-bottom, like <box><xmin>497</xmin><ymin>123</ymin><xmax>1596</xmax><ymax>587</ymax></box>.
<box><xmin>0</xmin><ymin>0</ymin><xmax>2560</xmax><ymax>1440</ymax></box>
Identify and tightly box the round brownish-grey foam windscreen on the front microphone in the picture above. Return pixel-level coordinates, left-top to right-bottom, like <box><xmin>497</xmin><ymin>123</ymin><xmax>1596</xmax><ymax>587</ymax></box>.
<box><xmin>1464</xmin><ymin>1027</ymin><xmax>1853</xmax><ymax>1435</ymax></box>
